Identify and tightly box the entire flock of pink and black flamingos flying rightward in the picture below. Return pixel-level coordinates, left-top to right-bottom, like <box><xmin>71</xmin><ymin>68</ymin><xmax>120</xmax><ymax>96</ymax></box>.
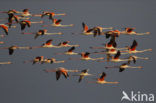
<box><xmin>0</xmin><ymin>9</ymin><xmax>152</xmax><ymax>84</ymax></box>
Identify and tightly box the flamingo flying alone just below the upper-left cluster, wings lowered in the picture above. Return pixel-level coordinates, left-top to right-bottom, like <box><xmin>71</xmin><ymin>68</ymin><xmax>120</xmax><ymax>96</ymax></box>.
<box><xmin>22</xmin><ymin>29</ymin><xmax>63</xmax><ymax>39</ymax></box>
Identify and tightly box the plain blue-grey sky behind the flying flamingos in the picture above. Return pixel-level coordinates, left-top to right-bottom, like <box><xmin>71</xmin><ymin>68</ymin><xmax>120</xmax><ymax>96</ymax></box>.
<box><xmin>0</xmin><ymin>0</ymin><xmax>156</xmax><ymax>103</ymax></box>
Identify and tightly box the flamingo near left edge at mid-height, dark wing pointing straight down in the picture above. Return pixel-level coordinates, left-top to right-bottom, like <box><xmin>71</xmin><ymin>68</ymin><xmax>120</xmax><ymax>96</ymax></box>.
<box><xmin>0</xmin><ymin>45</ymin><xmax>31</xmax><ymax>55</ymax></box>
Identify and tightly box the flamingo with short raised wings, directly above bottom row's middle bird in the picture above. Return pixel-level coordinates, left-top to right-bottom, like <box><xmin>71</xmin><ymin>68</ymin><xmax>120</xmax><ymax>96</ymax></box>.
<box><xmin>69</xmin><ymin>52</ymin><xmax>104</xmax><ymax>60</ymax></box>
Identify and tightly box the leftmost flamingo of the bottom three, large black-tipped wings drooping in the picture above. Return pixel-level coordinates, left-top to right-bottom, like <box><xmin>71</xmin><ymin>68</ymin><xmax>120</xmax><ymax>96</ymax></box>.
<box><xmin>44</xmin><ymin>67</ymin><xmax>79</xmax><ymax>80</ymax></box>
